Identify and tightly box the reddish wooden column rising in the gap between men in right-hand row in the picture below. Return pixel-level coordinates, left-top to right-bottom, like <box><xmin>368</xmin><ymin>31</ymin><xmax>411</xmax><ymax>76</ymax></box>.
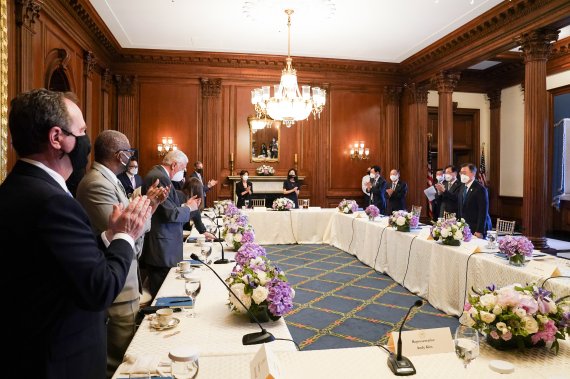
<box><xmin>399</xmin><ymin>84</ymin><xmax>428</xmax><ymax>217</ymax></box>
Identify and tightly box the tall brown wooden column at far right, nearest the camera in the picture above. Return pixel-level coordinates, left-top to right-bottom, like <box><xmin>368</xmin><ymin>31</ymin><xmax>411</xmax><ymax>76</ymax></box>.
<box><xmin>517</xmin><ymin>30</ymin><xmax>558</xmax><ymax>249</ymax></box>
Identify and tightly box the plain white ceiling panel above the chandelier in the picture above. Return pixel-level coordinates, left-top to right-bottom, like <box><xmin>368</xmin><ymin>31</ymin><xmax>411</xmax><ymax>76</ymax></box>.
<box><xmin>90</xmin><ymin>0</ymin><xmax>536</xmax><ymax>63</ymax></box>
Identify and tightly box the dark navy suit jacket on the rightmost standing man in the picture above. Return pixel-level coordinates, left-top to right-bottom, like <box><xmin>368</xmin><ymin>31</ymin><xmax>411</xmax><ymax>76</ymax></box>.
<box><xmin>457</xmin><ymin>180</ymin><xmax>491</xmax><ymax>237</ymax></box>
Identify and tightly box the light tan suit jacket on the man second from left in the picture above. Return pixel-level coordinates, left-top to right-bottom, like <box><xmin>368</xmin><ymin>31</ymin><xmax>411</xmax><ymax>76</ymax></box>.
<box><xmin>77</xmin><ymin>162</ymin><xmax>150</xmax><ymax>303</ymax></box>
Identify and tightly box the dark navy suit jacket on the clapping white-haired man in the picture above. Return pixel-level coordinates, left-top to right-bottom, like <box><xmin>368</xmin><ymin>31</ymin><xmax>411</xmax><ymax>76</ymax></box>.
<box><xmin>142</xmin><ymin>165</ymin><xmax>190</xmax><ymax>267</ymax></box>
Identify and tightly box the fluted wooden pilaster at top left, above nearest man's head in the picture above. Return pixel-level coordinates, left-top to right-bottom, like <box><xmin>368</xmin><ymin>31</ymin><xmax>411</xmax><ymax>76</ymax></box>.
<box><xmin>14</xmin><ymin>0</ymin><xmax>42</xmax><ymax>93</ymax></box>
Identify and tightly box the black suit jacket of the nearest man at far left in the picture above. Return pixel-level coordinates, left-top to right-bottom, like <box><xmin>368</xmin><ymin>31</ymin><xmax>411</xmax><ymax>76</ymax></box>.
<box><xmin>0</xmin><ymin>160</ymin><xmax>133</xmax><ymax>379</ymax></box>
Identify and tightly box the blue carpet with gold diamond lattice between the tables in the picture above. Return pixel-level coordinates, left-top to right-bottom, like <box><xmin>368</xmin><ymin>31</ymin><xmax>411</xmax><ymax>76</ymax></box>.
<box><xmin>264</xmin><ymin>245</ymin><xmax>459</xmax><ymax>350</ymax></box>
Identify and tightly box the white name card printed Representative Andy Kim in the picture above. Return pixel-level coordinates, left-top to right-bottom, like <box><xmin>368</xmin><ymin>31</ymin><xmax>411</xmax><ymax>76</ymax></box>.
<box><xmin>388</xmin><ymin>328</ymin><xmax>455</xmax><ymax>357</ymax></box>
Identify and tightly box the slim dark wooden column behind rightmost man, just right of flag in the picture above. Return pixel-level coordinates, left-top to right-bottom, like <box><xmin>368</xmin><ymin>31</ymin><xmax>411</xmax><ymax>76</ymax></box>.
<box><xmin>487</xmin><ymin>89</ymin><xmax>501</xmax><ymax>216</ymax></box>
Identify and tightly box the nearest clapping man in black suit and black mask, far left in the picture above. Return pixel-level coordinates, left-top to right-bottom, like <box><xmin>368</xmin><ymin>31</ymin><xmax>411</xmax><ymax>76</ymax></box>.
<box><xmin>0</xmin><ymin>89</ymin><xmax>151</xmax><ymax>379</ymax></box>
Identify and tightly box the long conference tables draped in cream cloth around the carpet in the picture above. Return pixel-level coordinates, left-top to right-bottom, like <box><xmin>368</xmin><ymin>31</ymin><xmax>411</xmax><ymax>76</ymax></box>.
<box><xmin>114</xmin><ymin>209</ymin><xmax>570</xmax><ymax>379</ymax></box>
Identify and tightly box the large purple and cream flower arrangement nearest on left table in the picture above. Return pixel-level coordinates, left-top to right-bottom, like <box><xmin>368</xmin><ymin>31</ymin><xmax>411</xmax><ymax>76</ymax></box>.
<box><xmin>226</xmin><ymin>243</ymin><xmax>295</xmax><ymax>322</ymax></box>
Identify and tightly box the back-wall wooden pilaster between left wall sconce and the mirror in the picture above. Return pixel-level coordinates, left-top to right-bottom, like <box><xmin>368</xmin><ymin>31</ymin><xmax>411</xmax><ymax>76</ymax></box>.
<box><xmin>198</xmin><ymin>78</ymin><xmax>221</xmax><ymax>205</ymax></box>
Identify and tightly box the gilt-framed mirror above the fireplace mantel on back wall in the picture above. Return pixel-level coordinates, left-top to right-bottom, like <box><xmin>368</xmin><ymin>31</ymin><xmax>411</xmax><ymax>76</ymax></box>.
<box><xmin>247</xmin><ymin>116</ymin><xmax>281</xmax><ymax>162</ymax></box>
